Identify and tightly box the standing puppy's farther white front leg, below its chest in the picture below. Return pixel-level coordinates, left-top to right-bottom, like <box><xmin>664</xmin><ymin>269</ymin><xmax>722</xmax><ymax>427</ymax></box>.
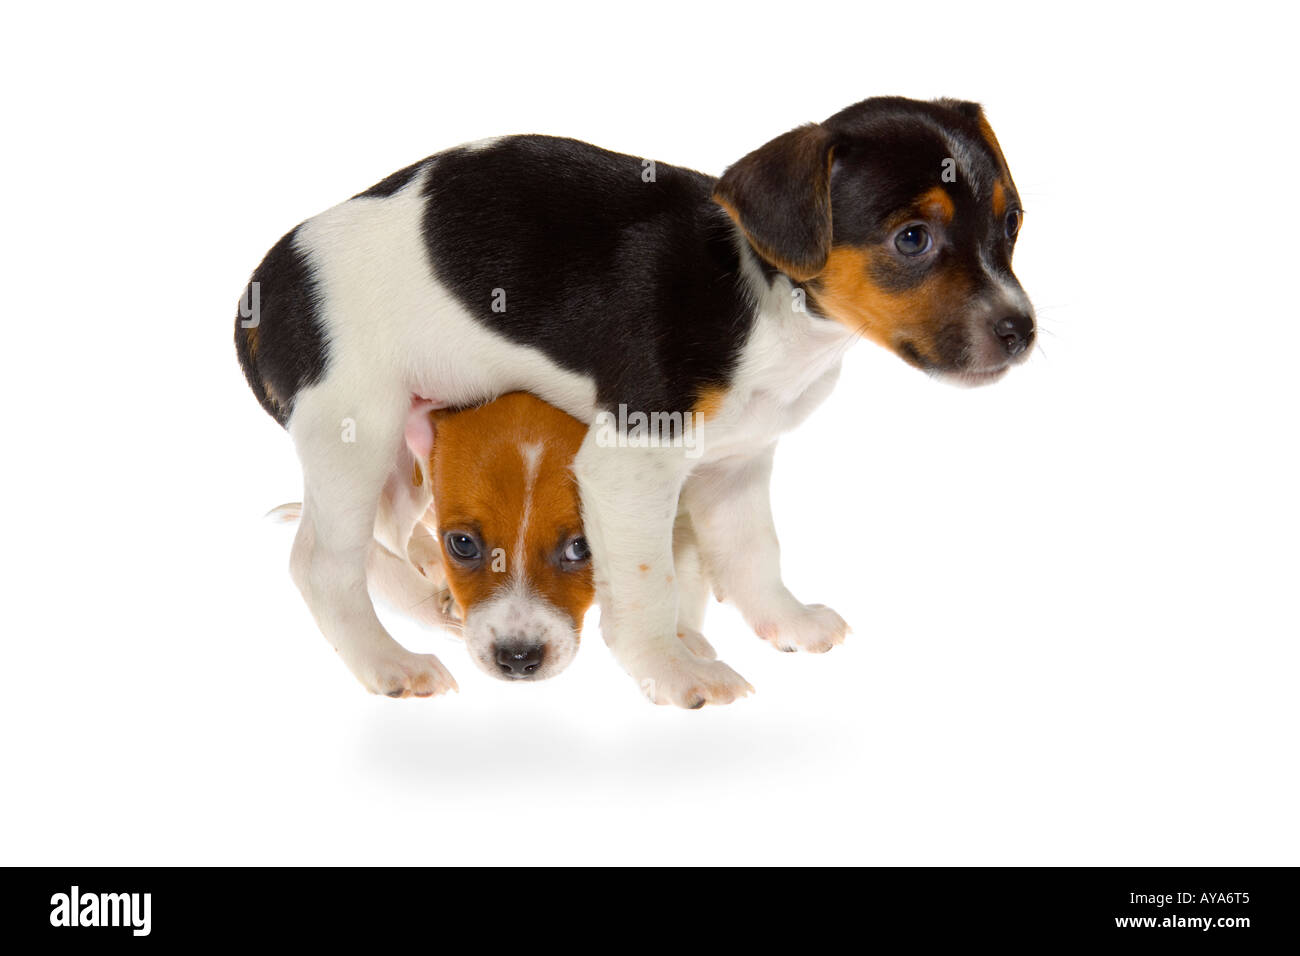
<box><xmin>683</xmin><ymin>445</ymin><xmax>849</xmax><ymax>653</ymax></box>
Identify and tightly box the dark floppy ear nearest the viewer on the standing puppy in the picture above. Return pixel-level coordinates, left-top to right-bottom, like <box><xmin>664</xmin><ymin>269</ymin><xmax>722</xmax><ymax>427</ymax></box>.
<box><xmin>714</xmin><ymin>124</ymin><xmax>833</xmax><ymax>282</ymax></box>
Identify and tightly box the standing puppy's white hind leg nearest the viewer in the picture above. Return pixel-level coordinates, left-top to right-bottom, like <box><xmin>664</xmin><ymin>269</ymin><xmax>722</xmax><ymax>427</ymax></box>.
<box><xmin>289</xmin><ymin>385</ymin><xmax>456</xmax><ymax>697</ymax></box>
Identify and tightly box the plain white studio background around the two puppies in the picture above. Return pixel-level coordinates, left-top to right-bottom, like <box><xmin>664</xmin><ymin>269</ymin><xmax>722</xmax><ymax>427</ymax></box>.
<box><xmin>0</xmin><ymin>1</ymin><xmax>1300</xmax><ymax>864</ymax></box>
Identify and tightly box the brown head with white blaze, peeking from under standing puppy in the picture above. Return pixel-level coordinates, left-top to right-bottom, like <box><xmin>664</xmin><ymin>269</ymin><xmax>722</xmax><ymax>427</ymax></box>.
<box><xmin>429</xmin><ymin>393</ymin><xmax>594</xmax><ymax>680</ymax></box>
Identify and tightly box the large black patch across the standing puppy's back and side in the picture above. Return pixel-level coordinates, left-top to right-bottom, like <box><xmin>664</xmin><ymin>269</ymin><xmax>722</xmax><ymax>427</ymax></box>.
<box><xmin>424</xmin><ymin>135</ymin><xmax>754</xmax><ymax>412</ymax></box>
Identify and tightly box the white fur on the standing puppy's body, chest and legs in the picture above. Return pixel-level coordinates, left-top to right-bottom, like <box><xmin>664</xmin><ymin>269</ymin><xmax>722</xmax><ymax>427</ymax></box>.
<box><xmin>289</xmin><ymin>161</ymin><xmax>854</xmax><ymax>706</ymax></box>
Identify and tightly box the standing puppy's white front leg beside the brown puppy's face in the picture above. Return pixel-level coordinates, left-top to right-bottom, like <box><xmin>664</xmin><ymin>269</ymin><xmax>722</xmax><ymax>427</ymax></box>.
<box><xmin>573</xmin><ymin>425</ymin><xmax>753</xmax><ymax>708</ymax></box>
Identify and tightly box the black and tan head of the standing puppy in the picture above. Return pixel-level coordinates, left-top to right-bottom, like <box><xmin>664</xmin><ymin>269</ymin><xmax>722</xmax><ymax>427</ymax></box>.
<box><xmin>714</xmin><ymin>98</ymin><xmax>1035</xmax><ymax>385</ymax></box>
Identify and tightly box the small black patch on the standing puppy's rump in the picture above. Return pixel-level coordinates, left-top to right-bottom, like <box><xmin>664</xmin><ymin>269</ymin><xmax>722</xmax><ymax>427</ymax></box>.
<box><xmin>235</xmin><ymin>225</ymin><xmax>332</xmax><ymax>425</ymax></box>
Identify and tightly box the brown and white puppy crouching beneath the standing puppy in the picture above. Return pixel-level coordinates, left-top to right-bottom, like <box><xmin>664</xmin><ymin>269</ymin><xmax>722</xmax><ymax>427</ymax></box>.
<box><xmin>273</xmin><ymin>393</ymin><xmax>594</xmax><ymax>697</ymax></box>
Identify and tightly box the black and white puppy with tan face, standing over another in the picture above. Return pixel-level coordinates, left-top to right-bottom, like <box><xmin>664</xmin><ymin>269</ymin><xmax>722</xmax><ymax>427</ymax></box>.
<box><xmin>235</xmin><ymin>98</ymin><xmax>1035</xmax><ymax>708</ymax></box>
